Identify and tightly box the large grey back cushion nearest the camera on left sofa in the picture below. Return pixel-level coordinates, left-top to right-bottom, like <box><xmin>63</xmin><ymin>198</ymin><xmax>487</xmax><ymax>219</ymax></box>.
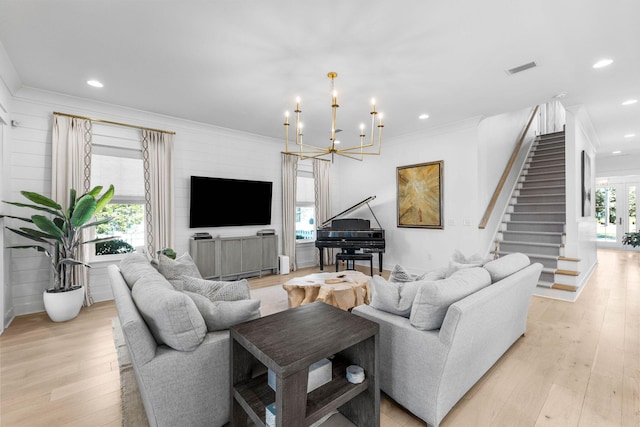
<box><xmin>131</xmin><ymin>275</ymin><xmax>207</xmax><ymax>351</ymax></box>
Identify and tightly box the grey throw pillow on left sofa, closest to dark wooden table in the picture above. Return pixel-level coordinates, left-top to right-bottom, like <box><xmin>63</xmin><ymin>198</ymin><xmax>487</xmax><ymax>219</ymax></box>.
<box><xmin>184</xmin><ymin>291</ymin><xmax>260</xmax><ymax>332</ymax></box>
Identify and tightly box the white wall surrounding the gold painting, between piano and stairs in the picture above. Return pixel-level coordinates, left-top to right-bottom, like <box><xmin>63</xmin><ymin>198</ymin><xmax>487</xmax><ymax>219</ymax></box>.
<box><xmin>333</xmin><ymin>118</ymin><xmax>484</xmax><ymax>272</ymax></box>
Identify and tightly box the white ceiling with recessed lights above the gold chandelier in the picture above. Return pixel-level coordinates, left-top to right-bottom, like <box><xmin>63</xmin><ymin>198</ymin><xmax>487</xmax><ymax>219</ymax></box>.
<box><xmin>0</xmin><ymin>0</ymin><xmax>640</xmax><ymax>160</ymax></box>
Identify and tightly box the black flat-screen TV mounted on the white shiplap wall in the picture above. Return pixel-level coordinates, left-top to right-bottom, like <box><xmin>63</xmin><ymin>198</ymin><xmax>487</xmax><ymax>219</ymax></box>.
<box><xmin>189</xmin><ymin>176</ymin><xmax>273</xmax><ymax>228</ymax></box>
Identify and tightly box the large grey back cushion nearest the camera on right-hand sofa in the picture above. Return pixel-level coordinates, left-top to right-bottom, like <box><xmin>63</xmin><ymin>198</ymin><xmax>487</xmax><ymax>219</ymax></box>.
<box><xmin>409</xmin><ymin>267</ymin><xmax>491</xmax><ymax>331</ymax></box>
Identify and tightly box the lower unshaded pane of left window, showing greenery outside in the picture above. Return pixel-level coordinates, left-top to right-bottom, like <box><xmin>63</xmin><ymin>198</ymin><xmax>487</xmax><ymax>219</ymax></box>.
<box><xmin>96</xmin><ymin>203</ymin><xmax>144</xmax><ymax>255</ymax></box>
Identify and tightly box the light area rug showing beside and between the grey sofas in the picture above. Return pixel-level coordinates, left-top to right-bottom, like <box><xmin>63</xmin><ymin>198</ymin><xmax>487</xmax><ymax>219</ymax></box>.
<box><xmin>112</xmin><ymin>285</ymin><xmax>288</xmax><ymax>427</ymax></box>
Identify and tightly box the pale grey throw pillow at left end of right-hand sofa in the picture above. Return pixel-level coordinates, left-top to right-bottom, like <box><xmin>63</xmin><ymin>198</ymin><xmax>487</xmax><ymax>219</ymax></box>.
<box><xmin>369</xmin><ymin>275</ymin><xmax>424</xmax><ymax>317</ymax></box>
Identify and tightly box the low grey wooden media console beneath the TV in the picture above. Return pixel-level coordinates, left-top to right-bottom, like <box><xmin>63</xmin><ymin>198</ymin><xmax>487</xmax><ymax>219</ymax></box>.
<box><xmin>189</xmin><ymin>234</ymin><xmax>278</xmax><ymax>279</ymax></box>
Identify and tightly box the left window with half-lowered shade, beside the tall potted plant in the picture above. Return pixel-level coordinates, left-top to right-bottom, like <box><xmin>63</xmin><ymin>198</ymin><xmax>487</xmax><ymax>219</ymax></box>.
<box><xmin>91</xmin><ymin>126</ymin><xmax>145</xmax><ymax>256</ymax></box>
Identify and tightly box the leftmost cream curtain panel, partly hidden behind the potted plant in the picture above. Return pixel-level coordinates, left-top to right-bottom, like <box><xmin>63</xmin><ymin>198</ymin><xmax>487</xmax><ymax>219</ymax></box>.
<box><xmin>51</xmin><ymin>115</ymin><xmax>93</xmax><ymax>306</ymax></box>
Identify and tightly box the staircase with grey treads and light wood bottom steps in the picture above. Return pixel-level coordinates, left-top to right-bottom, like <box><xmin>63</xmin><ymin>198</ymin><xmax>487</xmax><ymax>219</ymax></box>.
<box><xmin>494</xmin><ymin>131</ymin><xmax>580</xmax><ymax>292</ymax></box>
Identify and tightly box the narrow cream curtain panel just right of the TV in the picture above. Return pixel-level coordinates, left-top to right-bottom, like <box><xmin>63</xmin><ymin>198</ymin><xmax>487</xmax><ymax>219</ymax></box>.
<box><xmin>282</xmin><ymin>153</ymin><xmax>298</xmax><ymax>271</ymax></box>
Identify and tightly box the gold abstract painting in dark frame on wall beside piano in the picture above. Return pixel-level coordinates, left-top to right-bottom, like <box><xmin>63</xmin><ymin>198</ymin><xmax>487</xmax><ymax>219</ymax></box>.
<box><xmin>397</xmin><ymin>160</ymin><xmax>444</xmax><ymax>229</ymax></box>
